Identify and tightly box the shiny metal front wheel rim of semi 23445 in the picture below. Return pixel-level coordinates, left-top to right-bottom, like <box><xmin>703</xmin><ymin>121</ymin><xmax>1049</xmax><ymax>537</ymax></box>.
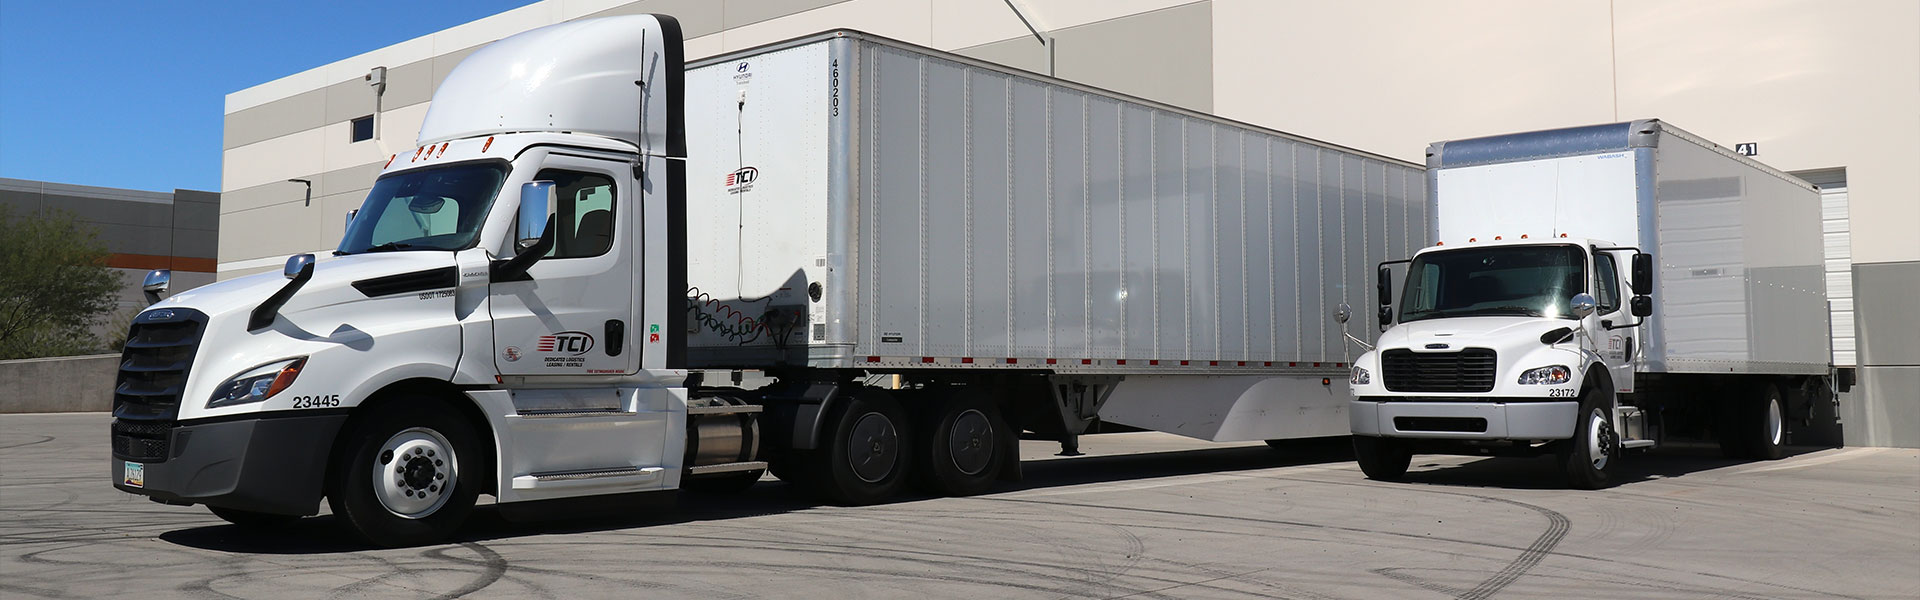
<box><xmin>372</xmin><ymin>427</ymin><xmax>459</xmax><ymax>519</ymax></box>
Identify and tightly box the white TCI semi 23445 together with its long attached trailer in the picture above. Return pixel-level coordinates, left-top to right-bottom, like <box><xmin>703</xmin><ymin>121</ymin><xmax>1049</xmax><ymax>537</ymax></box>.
<box><xmin>109</xmin><ymin>15</ymin><xmax>1427</xmax><ymax>544</ymax></box>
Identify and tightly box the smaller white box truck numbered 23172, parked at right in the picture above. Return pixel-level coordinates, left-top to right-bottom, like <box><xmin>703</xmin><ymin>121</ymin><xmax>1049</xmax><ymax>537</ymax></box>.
<box><xmin>1342</xmin><ymin>119</ymin><xmax>1837</xmax><ymax>488</ymax></box>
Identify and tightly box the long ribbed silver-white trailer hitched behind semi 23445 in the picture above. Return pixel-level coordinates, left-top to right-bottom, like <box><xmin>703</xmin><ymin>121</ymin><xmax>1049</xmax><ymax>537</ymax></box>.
<box><xmin>687</xmin><ymin>31</ymin><xmax>1428</xmax><ymax>440</ymax></box>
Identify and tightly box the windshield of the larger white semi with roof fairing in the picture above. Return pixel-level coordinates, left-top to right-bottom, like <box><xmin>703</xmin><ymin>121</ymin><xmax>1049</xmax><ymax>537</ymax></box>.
<box><xmin>334</xmin><ymin>162</ymin><xmax>507</xmax><ymax>254</ymax></box>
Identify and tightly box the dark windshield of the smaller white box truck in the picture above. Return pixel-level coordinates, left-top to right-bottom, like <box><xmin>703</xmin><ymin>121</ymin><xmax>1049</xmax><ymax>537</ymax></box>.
<box><xmin>1400</xmin><ymin>246</ymin><xmax>1586</xmax><ymax>321</ymax></box>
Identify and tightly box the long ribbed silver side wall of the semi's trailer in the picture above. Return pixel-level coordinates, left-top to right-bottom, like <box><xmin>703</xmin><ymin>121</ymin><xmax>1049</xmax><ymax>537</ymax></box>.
<box><xmin>848</xmin><ymin>38</ymin><xmax>1428</xmax><ymax>371</ymax></box>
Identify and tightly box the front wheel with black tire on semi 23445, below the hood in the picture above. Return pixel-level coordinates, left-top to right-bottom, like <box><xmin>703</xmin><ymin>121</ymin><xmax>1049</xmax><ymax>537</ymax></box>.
<box><xmin>326</xmin><ymin>398</ymin><xmax>486</xmax><ymax>546</ymax></box>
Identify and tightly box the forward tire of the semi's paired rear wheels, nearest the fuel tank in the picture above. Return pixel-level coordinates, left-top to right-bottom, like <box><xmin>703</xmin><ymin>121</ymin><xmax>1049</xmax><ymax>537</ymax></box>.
<box><xmin>801</xmin><ymin>388</ymin><xmax>914</xmax><ymax>506</ymax></box>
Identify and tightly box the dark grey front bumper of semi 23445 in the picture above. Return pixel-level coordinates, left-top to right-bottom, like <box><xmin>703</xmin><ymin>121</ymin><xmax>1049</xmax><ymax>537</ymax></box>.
<box><xmin>109</xmin><ymin>413</ymin><xmax>348</xmax><ymax>515</ymax></box>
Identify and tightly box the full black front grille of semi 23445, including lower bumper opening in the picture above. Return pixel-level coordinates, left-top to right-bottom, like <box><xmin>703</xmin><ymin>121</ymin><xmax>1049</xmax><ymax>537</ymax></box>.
<box><xmin>113</xmin><ymin>308</ymin><xmax>207</xmax><ymax>462</ymax></box>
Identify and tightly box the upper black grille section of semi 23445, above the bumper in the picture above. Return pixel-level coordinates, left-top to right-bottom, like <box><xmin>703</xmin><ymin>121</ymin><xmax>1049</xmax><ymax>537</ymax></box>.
<box><xmin>113</xmin><ymin>308</ymin><xmax>207</xmax><ymax>421</ymax></box>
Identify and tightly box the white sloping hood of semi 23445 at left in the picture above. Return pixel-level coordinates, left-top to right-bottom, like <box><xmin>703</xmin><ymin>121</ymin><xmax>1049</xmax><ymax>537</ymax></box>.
<box><xmin>148</xmin><ymin>250</ymin><xmax>472</xmax><ymax>421</ymax></box>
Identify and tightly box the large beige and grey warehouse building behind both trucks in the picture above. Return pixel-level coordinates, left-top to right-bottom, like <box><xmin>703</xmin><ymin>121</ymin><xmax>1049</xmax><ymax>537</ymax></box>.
<box><xmin>217</xmin><ymin>0</ymin><xmax>1920</xmax><ymax>446</ymax></box>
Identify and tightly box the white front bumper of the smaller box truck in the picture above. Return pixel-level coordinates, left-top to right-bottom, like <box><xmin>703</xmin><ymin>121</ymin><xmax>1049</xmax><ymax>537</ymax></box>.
<box><xmin>1348</xmin><ymin>398</ymin><xmax>1580</xmax><ymax>440</ymax></box>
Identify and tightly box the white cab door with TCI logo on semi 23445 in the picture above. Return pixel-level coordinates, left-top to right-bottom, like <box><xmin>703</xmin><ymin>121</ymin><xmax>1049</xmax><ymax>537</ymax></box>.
<box><xmin>490</xmin><ymin>154</ymin><xmax>639</xmax><ymax>375</ymax></box>
